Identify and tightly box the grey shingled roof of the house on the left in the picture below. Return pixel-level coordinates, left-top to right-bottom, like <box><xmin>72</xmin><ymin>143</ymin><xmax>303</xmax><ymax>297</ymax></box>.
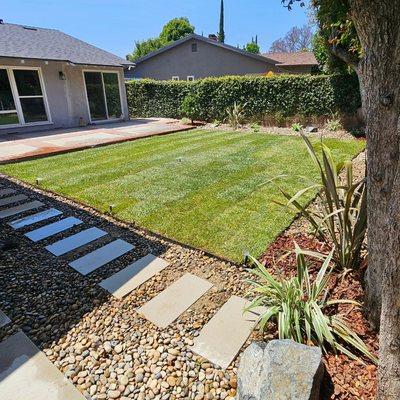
<box><xmin>0</xmin><ymin>23</ymin><xmax>133</xmax><ymax>67</ymax></box>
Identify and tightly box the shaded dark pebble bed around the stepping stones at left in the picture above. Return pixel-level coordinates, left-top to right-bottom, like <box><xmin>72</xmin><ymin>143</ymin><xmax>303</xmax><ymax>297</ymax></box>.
<box><xmin>0</xmin><ymin>178</ymin><xmax>170</xmax><ymax>372</ymax></box>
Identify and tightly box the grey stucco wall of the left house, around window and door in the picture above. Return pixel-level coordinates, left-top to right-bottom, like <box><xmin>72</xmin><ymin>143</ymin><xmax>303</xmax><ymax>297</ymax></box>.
<box><xmin>0</xmin><ymin>58</ymin><xmax>129</xmax><ymax>134</ymax></box>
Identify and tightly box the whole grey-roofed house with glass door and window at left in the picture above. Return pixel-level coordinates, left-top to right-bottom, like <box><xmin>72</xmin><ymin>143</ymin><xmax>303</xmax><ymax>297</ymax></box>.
<box><xmin>0</xmin><ymin>20</ymin><xmax>134</xmax><ymax>135</ymax></box>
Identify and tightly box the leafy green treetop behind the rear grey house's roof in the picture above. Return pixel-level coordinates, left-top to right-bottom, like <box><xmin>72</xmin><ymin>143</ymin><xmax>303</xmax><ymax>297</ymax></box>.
<box><xmin>126</xmin><ymin>17</ymin><xmax>194</xmax><ymax>61</ymax></box>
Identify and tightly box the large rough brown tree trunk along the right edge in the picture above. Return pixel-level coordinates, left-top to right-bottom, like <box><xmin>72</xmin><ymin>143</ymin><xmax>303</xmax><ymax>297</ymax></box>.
<box><xmin>349</xmin><ymin>0</ymin><xmax>400</xmax><ymax>400</ymax></box>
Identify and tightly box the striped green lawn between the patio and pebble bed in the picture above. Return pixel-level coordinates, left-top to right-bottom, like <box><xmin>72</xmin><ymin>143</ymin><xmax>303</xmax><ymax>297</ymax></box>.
<box><xmin>0</xmin><ymin>130</ymin><xmax>364</xmax><ymax>261</ymax></box>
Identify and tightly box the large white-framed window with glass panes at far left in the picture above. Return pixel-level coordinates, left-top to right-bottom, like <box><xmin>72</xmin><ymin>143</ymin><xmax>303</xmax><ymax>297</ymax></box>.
<box><xmin>0</xmin><ymin>67</ymin><xmax>50</xmax><ymax>127</ymax></box>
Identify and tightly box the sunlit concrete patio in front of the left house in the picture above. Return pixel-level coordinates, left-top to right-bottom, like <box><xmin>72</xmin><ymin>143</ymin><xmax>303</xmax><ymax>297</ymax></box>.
<box><xmin>0</xmin><ymin>118</ymin><xmax>194</xmax><ymax>163</ymax></box>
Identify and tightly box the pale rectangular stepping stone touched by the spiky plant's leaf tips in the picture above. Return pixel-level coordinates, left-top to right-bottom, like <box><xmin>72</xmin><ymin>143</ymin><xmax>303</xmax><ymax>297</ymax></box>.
<box><xmin>192</xmin><ymin>296</ymin><xmax>263</xmax><ymax>369</ymax></box>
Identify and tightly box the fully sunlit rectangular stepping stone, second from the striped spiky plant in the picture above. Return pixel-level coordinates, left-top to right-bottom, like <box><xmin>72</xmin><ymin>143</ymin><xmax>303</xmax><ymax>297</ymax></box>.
<box><xmin>137</xmin><ymin>274</ymin><xmax>213</xmax><ymax>328</ymax></box>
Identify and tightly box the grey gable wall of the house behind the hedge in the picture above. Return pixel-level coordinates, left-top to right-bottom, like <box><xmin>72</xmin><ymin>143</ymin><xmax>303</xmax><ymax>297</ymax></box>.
<box><xmin>125</xmin><ymin>39</ymin><xmax>278</xmax><ymax>80</ymax></box>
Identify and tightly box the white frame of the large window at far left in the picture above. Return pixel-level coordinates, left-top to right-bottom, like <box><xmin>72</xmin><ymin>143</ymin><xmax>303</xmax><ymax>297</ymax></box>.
<box><xmin>0</xmin><ymin>65</ymin><xmax>53</xmax><ymax>129</ymax></box>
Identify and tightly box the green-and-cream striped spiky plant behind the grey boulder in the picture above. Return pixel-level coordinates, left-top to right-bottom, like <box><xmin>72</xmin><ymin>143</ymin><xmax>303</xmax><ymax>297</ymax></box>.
<box><xmin>247</xmin><ymin>244</ymin><xmax>377</xmax><ymax>363</ymax></box>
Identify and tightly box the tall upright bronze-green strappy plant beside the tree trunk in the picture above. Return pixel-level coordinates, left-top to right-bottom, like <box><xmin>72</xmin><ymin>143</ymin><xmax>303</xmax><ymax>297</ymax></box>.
<box><xmin>281</xmin><ymin>134</ymin><xmax>367</xmax><ymax>271</ymax></box>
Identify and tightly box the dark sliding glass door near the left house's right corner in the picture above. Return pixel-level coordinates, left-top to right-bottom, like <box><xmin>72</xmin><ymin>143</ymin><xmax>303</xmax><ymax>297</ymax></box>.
<box><xmin>84</xmin><ymin>71</ymin><xmax>122</xmax><ymax>121</ymax></box>
